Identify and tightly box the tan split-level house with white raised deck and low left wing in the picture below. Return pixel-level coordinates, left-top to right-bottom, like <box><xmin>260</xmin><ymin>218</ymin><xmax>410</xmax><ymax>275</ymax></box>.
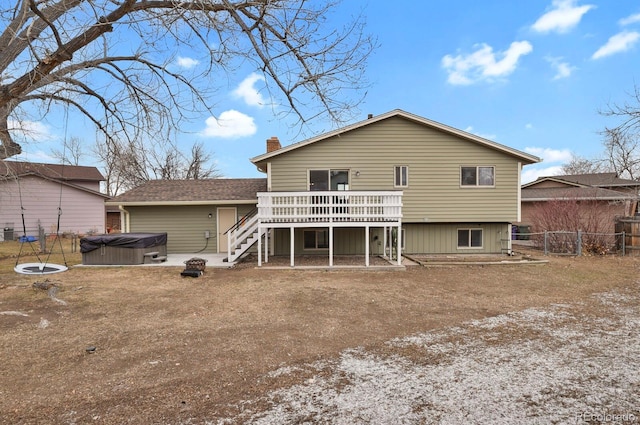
<box><xmin>108</xmin><ymin>110</ymin><xmax>539</xmax><ymax>266</ymax></box>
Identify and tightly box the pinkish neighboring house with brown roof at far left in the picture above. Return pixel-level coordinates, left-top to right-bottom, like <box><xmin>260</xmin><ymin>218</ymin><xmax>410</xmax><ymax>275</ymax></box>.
<box><xmin>0</xmin><ymin>161</ymin><xmax>108</xmax><ymax>239</ymax></box>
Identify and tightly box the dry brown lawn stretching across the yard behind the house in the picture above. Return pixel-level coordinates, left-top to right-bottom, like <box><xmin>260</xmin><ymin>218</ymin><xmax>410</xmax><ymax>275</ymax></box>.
<box><xmin>0</xmin><ymin>244</ymin><xmax>640</xmax><ymax>424</ymax></box>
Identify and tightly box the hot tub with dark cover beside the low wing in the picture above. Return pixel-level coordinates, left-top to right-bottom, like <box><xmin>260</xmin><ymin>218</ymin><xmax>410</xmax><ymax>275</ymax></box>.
<box><xmin>80</xmin><ymin>233</ymin><xmax>167</xmax><ymax>265</ymax></box>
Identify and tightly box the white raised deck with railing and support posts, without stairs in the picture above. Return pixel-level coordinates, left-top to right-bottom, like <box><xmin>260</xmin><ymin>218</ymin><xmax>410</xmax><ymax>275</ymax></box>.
<box><xmin>257</xmin><ymin>191</ymin><xmax>402</xmax><ymax>267</ymax></box>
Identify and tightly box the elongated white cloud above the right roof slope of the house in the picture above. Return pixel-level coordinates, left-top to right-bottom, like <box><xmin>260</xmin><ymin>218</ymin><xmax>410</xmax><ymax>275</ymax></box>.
<box><xmin>442</xmin><ymin>41</ymin><xmax>533</xmax><ymax>85</ymax></box>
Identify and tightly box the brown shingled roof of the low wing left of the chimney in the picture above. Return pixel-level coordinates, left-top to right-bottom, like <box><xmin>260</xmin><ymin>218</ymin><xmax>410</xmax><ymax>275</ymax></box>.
<box><xmin>109</xmin><ymin>179</ymin><xmax>267</xmax><ymax>204</ymax></box>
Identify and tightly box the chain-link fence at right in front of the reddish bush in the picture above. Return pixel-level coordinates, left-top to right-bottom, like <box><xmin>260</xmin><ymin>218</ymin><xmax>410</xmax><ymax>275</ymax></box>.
<box><xmin>513</xmin><ymin>230</ymin><xmax>640</xmax><ymax>255</ymax></box>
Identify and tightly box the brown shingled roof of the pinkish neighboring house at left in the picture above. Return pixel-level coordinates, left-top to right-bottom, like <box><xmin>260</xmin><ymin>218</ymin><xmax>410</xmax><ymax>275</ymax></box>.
<box><xmin>0</xmin><ymin>161</ymin><xmax>104</xmax><ymax>182</ymax></box>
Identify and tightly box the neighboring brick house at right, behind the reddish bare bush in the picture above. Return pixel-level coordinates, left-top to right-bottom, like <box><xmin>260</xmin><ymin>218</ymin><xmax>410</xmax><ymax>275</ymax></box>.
<box><xmin>521</xmin><ymin>173</ymin><xmax>640</xmax><ymax>232</ymax></box>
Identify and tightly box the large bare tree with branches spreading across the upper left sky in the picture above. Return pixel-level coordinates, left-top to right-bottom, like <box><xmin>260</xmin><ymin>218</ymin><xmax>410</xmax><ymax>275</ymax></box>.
<box><xmin>0</xmin><ymin>0</ymin><xmax>376</xmax><ymax>159</ymax></box>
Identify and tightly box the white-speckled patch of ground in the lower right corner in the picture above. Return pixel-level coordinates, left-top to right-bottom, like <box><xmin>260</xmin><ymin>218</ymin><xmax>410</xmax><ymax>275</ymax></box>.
<box><xmin>218</xmin><ymin>283</ymin><xmax>640</xmax><ymax>424</ymax></box>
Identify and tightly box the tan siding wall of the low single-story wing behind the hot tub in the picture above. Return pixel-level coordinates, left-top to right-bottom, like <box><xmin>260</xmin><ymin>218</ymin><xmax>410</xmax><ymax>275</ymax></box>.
<box><xmin>126</xmin><ymin>205</ymin><xmax>255</xmax><ymax>254</ymax></box>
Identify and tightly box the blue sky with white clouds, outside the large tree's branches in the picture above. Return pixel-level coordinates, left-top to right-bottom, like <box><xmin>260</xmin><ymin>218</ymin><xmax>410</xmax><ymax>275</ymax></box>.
<box><xmin>15</xmin><ymin>0</ymin><xmax>640</xmax><ymax>182</ymax></box>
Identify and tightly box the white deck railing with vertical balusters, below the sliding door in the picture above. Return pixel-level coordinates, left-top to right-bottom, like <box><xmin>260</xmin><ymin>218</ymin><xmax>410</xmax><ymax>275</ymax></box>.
<box><xmin>258</xmin><ymin>191</ymin><xmax>402</xmax><ymax>223</ymax></box>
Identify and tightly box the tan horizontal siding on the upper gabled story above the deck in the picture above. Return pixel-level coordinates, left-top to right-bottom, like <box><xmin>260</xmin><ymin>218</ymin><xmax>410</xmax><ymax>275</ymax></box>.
<box><xmin>269</xmin><ymin>117</ymin><xmax>519</xmax><ymax>223</ymax></box>
